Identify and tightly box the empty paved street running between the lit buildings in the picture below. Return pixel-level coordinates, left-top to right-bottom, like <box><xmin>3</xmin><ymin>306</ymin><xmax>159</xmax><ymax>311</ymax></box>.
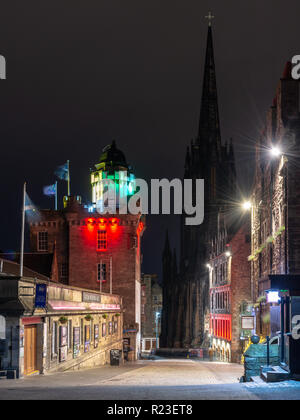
<box><xmin>0</xmin><ymin>359</ymin><xmax>300</xmax><ymax>400</ymax></box>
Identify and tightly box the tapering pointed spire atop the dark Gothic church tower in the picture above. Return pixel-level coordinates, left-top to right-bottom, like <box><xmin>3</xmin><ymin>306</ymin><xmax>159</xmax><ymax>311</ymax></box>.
<box><xmin>198</xmin><ymin>18</ymin><xmax>221</xmax><ymax>156</ymax></box>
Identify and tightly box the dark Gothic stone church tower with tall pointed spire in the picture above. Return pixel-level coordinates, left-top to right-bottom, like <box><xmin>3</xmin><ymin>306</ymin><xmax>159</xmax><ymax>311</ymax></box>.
<box><xmin>161</xmin><ymin>24</ymin><xmax>236</xmax><ymax>348</ymax></box>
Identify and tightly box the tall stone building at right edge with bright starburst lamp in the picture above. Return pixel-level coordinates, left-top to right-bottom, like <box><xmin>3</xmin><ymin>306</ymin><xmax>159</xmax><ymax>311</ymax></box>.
<box><xmin>249</xmin><ymin>63</ymin><xmax>300</xmax><ymax>336</ymax></box>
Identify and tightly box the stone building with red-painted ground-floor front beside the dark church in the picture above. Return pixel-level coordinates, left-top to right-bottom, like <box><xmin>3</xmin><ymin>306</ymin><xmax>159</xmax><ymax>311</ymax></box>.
<box><xmin>208</xmin><ymin>213</ymin><xmax>252</xmax><ymax>363</ymax></box>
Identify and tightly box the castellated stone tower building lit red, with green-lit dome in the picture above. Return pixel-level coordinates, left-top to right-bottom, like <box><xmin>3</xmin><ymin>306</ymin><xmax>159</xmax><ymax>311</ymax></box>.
<box><xmin>30</xmin><ymin>142</ymin><xmax>145</xmax><ymax>360</ymax></box>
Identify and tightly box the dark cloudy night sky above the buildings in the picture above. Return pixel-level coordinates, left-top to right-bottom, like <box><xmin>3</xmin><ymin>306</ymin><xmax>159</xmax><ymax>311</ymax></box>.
<box><xmin>0</xmin><ymin>0</ymin><xmax>300</xmax><ymax>278</ymax></box>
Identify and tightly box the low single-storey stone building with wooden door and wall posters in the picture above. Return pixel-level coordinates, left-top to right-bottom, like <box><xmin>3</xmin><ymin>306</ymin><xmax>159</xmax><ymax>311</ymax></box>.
<box><xmin>0</xmin><ymin>274</ymin><xmax>123</xmax><ymax>378</ymax></box>
